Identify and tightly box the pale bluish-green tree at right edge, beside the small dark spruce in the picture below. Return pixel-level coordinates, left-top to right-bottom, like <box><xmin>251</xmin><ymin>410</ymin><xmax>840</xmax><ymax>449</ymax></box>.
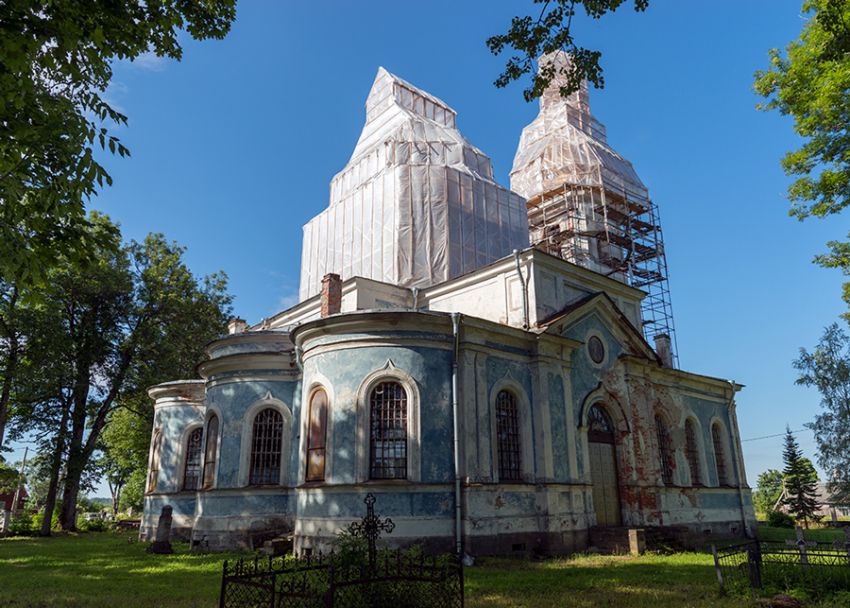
<box><xmin>794</xmin><ymin>323</ymin><xmax>850</xmax><ymax>501</ymax></box>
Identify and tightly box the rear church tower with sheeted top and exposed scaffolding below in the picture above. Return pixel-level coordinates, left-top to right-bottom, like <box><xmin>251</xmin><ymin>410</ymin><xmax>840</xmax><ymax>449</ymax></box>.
<box><xmin>511</xmin><ymin>51</ymin><xmax>676</xmax><ymax>361</ymax></box>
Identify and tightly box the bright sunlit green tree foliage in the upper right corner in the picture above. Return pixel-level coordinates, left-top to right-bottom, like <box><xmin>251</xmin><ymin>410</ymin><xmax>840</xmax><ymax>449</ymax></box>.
<box><xmin>755</xmin><ymin>0</ymin><xmax>850</xmax><ymax>305</ymax></box>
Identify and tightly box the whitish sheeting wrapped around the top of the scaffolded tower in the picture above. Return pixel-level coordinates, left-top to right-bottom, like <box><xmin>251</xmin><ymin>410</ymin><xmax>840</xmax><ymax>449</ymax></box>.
<box><xmin>511</xmin><ymin>51</ymin><xmax>649</xmax><ymax>201</ymax></box>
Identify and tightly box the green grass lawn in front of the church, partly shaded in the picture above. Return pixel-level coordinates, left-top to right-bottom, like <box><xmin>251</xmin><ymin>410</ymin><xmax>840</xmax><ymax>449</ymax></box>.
<box><xmin>0</xmin><ymin>530</ymin><xmax>850</xmax><ymax>608</ymax></box>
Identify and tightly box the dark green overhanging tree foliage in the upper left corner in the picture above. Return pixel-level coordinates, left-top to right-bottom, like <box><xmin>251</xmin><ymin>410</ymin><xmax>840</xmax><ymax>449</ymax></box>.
<box><xmin>0</xmin><ymin>0</ymin><xmax>236</xmax><ymax>282</ymax></box>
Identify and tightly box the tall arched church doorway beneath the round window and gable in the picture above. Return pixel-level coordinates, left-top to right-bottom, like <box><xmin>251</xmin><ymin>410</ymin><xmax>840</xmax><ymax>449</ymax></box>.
<box><xmin>587</xmin><ymin>405</ymin><xmax>622</xmax><ymax>526</ymax></box>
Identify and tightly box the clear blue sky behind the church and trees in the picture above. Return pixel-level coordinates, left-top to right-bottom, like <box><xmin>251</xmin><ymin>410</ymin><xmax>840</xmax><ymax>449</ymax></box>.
<box><xmin>9</xmin><ymin>0</ymin><xmax>848</xmax><ymax>491</ymax></box>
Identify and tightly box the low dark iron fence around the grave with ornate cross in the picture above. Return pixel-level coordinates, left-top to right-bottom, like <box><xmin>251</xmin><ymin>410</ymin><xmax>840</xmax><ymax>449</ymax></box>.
<box><xmin>219</xmin><ymin>550</ymin><xmax>463</xmax><ymax>608</ymax></box>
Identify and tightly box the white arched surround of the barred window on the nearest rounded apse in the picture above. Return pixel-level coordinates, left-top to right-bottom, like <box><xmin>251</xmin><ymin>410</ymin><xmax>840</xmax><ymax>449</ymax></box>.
<box><xmin>352</xmin><ymin>360</ymin><xmax>422</xmax><ymax>483</ymax></box>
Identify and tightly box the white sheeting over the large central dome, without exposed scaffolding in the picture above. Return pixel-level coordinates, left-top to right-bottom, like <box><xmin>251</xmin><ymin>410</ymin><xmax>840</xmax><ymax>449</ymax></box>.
<box><xmin>300</xmin><ymin>68</ymin><xmax>528</xmax><ymax>300</ymax></box>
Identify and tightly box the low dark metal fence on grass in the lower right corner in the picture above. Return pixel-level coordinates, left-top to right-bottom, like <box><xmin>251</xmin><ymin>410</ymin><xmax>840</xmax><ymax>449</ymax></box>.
<box><xmin>711</xmin><ymin>540</ymin><xmax>850</xmax><ymax>593</ymax></box>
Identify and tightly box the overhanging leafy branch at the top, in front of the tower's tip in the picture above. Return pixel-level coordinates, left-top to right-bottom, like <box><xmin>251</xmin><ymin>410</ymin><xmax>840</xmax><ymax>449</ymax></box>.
<box><xmin>487</xmin><ymin>0</ymin><xmax>649</xmax><ymax>101</ymax></box>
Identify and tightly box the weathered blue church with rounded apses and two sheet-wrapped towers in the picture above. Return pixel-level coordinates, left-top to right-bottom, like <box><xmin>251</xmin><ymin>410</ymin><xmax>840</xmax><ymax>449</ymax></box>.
<box><xmin>141</xmin><ymin>54</ymin><xmax>755</xmax><ymax>555</ymax></box>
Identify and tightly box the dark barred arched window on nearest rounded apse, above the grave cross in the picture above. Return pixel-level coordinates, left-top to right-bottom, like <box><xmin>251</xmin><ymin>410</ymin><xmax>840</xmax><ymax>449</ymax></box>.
<box><xmin>369</xmin><ymin>382</ymin><xmax>407</xmax><ymax>479</ymax></box>
